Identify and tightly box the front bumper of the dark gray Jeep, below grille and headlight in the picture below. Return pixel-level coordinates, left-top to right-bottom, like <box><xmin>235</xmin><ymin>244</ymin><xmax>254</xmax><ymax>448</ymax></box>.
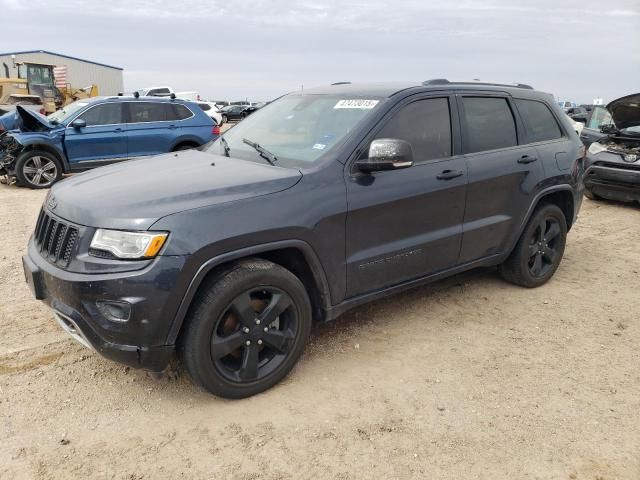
<box><xmin>23</xmin><ymin>240</ymin><xmax>185</xmax><ymax>372</ymax></box>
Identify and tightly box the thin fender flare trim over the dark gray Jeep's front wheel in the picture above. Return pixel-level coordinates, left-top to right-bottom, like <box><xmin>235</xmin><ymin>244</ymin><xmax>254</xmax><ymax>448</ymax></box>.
<box><xmin>167</xmin><ymin>240</ymin><xmax>331</xmax><ymax>345</ymax></box>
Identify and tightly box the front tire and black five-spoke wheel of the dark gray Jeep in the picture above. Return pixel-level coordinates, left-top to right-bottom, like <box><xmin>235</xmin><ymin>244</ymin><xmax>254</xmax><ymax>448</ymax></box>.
<box><xmin>179</xmin><ymin>259</ymin><xmax>311</xmax><ymax>398</ymax></box>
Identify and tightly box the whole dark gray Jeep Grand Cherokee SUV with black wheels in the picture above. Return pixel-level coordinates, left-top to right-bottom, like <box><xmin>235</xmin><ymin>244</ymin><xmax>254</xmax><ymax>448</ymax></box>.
<box><xmin>24</xmin><ymin>80</ymin><xmax>584</xmax><ymax>398</ymax></box>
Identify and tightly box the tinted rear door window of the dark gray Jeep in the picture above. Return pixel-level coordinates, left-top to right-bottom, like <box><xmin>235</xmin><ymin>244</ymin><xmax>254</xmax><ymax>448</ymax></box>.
<box><xmin>462</xmin><ymin>97</ymin><xmax>518</xmax><ymax>153</ymax></box>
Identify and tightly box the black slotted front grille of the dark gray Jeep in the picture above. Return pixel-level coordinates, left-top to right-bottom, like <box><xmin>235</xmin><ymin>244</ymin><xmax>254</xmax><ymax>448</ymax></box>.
<box><xmin>34</xmin><ymin>210</ymin><xmax>78</xmax><ymax>267</ymax></box>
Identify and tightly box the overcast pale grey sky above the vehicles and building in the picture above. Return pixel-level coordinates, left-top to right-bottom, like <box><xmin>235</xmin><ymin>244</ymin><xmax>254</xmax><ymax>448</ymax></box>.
<box><xmin>0</xmin><ymin>0</ymin><xmax>640</xmax><ymax>103</ymax></box>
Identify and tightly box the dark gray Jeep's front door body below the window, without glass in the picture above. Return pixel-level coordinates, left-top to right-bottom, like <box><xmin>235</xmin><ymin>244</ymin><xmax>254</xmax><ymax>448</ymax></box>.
<box><xmin>347</xmin><ymin>158</ymin><xmax>467</xmax><ymax>296</ymax></box>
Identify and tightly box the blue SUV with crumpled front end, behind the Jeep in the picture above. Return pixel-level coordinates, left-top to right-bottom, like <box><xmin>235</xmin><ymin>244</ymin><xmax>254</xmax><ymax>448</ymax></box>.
<box><xmin>0</xmin><ymin>96</ymin><xmax>220</xmax><ymax>188</ymax></box>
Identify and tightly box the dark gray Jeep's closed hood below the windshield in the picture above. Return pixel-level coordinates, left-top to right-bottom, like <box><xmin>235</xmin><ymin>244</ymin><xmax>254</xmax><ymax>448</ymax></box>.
<box><xmin>47</xmin><ymin>150</ymin><xmax>302</xmax><ymax>230</ymax></box>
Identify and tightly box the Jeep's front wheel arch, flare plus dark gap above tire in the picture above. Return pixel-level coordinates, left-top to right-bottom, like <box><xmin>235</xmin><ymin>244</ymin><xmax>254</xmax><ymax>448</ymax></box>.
<box><xmin>167</xmin><ymin>240</ymin><xmax>331</xmax><ymax>345</ymax></box>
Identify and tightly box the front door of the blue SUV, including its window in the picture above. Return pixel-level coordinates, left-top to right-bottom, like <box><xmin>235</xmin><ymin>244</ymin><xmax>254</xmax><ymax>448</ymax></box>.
<box><xmin>64</xmin><ymin>103</ymin><xmax>127</xmax><ymax>166</ymax></box>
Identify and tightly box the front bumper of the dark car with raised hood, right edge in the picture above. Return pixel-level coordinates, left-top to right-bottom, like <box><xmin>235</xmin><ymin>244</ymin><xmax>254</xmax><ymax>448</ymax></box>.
<box><xmin>584</xmin><ymin>164</ymin><xmax>640</xmax><ymax>202</ymax></box>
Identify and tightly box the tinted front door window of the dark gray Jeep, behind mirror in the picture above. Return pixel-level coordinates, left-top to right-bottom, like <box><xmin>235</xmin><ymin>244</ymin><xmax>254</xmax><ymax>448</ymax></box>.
<box><xmin>376</xmin><ymin>98</ymin><xmax>451</xmax><ymax>162</ymax></box>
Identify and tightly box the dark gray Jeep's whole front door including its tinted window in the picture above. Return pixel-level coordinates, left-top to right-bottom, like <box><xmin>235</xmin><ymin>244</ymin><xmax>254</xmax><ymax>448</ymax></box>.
<box><xmin>346</xmin><ymin>96</ymin><xmax>467</xmax><ymax>296</ymax></box>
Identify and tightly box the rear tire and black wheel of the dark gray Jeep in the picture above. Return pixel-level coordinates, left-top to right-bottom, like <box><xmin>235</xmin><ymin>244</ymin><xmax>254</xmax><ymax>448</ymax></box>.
<box><xmin>499</xmin><ymin>204</ymin><xmax>567</xmax><ymax>288</ymax></box>
